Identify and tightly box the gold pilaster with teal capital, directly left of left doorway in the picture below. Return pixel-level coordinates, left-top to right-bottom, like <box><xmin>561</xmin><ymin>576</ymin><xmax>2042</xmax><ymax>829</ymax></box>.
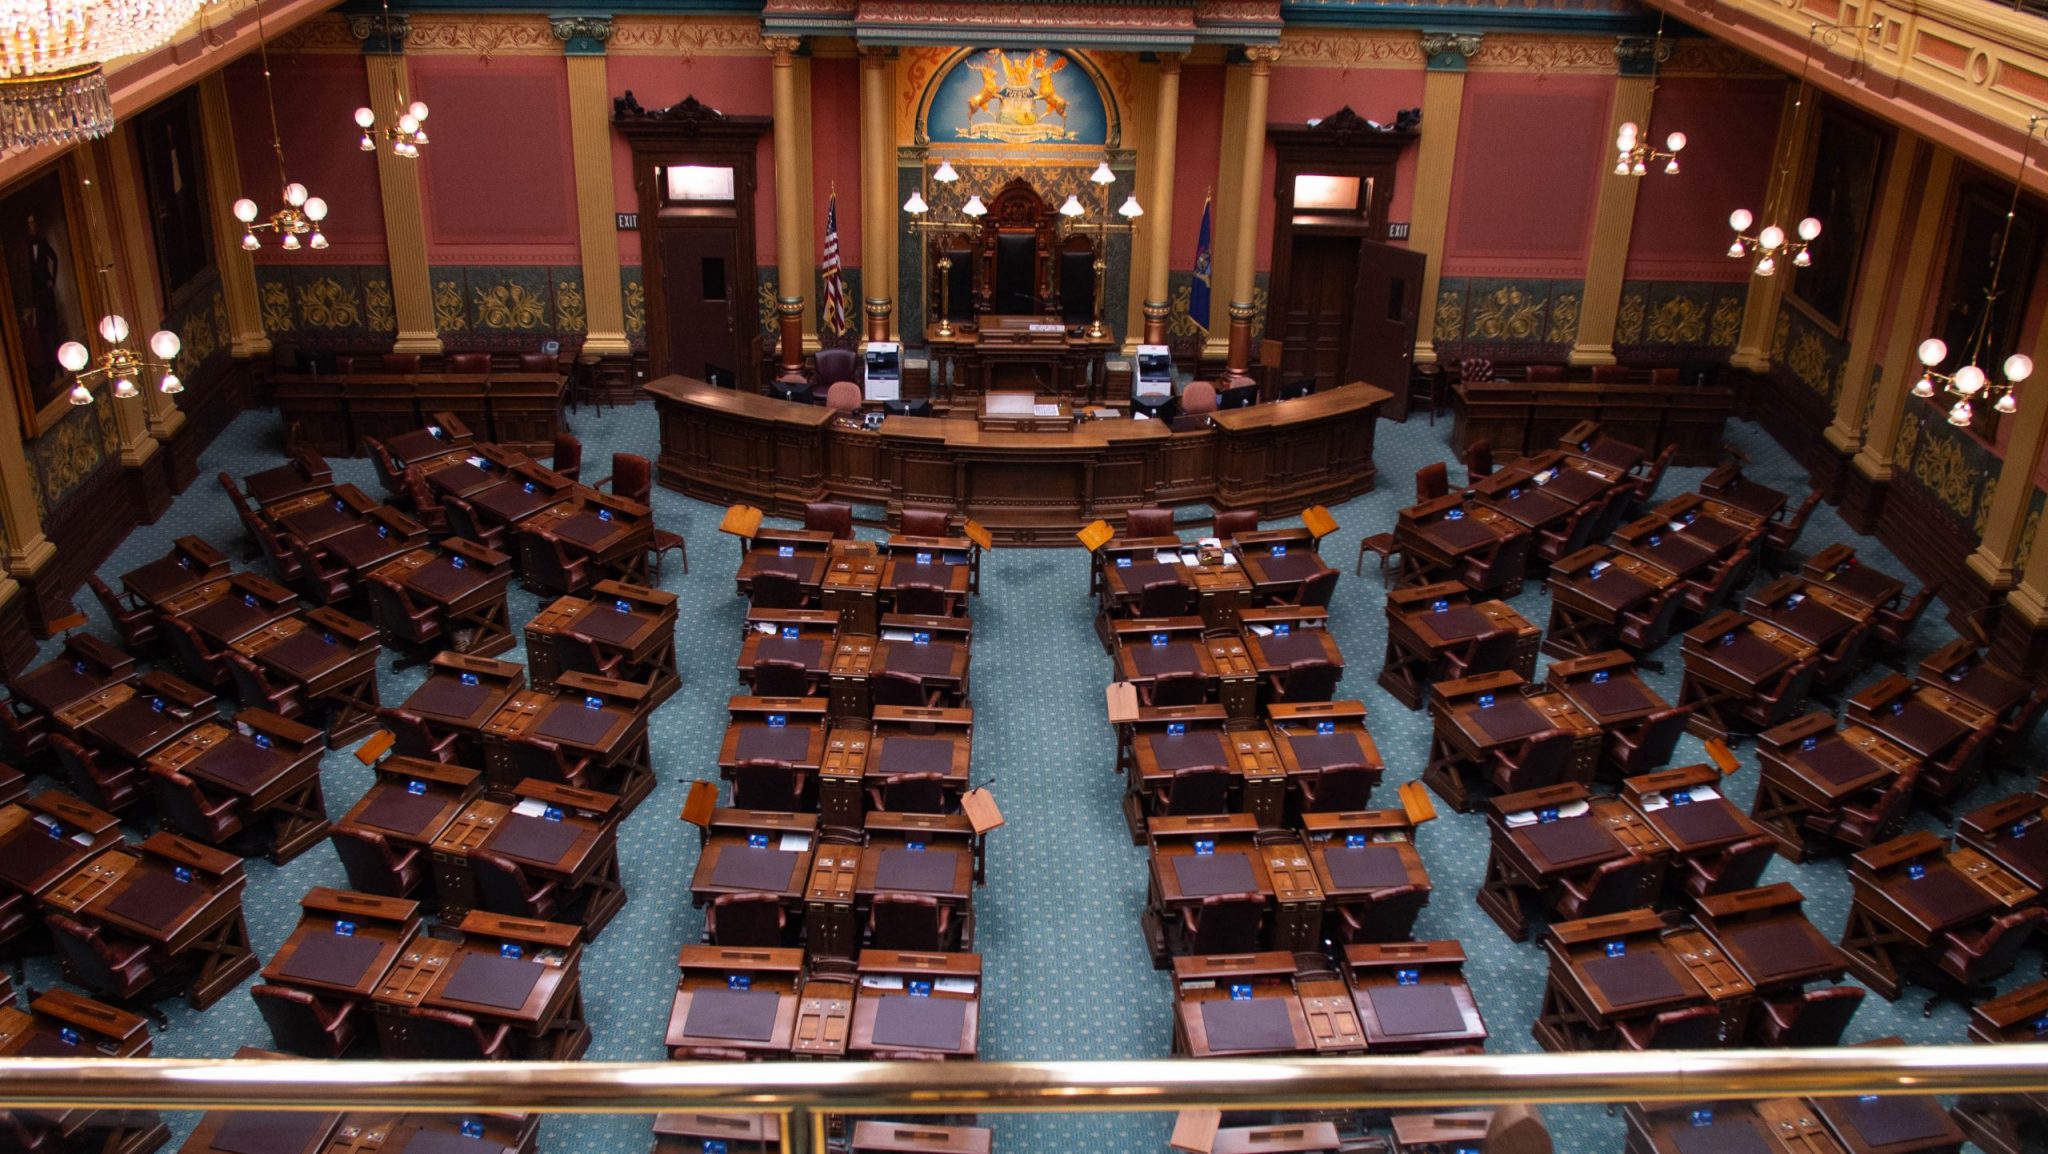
<box><xmin>549</xmin><ymin>16</ymin><xmax>633</xmax><ymax>357</ymax></box>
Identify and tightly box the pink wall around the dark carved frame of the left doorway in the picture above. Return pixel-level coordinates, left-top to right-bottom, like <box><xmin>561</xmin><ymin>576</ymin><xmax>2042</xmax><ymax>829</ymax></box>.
<box><xmin>604</xmin><ymin>53</ymin><xmax>774</xmax><ymax>266</ymax></box>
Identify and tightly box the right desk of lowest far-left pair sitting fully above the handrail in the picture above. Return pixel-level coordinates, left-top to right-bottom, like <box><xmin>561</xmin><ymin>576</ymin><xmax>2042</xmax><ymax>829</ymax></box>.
<box><xmin>57</xmin><ymin>832</ymin><xmax>260</xmax><ymax>1011</ymax></box>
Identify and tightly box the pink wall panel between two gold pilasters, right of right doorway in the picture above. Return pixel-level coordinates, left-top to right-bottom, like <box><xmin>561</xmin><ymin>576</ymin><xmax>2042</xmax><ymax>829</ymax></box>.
<box><xmin>1423</xmin><ymin>72</ymin><xmax>1614</xmax><ymax>279</ymax></box>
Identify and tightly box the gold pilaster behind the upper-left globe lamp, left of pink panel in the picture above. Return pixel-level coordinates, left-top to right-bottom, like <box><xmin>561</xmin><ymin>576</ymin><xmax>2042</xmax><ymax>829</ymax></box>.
<box><xmin>350</xmin><ymin>14</ymin><xmax>438</xmax><ymax>353</ymax></box>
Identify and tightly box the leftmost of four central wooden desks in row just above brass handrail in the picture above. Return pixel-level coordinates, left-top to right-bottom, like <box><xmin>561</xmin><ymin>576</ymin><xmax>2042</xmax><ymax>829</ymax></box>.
<box><xmin>662</xmin><ymin>945</ymin><xmax>803</xmax><ymax>1058</ymax></box>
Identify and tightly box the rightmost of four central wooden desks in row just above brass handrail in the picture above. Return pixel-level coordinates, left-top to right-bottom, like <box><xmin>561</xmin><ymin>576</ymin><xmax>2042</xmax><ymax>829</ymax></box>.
<box><xmin>1339</xmin><ymin>941</ymin><xmax>1487</xmax><ymax>1054</ymax></box>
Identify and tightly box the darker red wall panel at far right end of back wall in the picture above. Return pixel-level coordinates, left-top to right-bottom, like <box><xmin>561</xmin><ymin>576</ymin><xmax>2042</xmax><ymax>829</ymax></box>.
<box><xmin>1610</xmin><ymin>78</ymin><xmax>1784</xmax><ymax>283</ymax></box>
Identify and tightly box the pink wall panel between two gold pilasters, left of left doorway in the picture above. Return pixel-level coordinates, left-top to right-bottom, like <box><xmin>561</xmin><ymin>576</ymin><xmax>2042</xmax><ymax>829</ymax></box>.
<box><xmin>412</xmin><ymin>55</ymin><xmax>582</xmax><ymax>264</ymax></box>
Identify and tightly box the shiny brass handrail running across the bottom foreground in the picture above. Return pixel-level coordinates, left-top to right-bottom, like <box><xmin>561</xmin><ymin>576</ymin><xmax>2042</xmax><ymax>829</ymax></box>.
<box><xmin>0</xmin><ymin>1045</ymin><xmax>2048</xmax><ymax>1115</ymax></box>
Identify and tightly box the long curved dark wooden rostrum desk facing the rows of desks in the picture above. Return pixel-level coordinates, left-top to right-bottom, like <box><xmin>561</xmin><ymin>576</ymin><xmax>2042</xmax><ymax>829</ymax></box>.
<box><xmin>645</xmin><ymin>377</ymin><xmax>1391</xmax><ymax>545</ymax></box>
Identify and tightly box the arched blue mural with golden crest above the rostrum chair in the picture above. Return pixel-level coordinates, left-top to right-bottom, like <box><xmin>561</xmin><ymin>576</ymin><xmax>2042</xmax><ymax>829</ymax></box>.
<box><xmin>918</xmin><ymin>47</ymin><xmax>1122</xmax><ymax>148</ymax></box>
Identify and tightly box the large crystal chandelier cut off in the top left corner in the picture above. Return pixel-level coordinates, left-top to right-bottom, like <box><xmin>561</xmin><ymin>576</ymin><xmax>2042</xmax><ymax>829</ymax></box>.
<box><xmin>0</xmin><ymin>0</ymin><xmax>205</xmax><ymax>152</ymax></box>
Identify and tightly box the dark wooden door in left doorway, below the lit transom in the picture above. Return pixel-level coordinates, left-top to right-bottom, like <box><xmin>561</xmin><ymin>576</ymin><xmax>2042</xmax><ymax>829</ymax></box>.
<box><xmin>657</xmin><ymin>225</ymin><xmax>754</xmax><ymax>387</ymax></box>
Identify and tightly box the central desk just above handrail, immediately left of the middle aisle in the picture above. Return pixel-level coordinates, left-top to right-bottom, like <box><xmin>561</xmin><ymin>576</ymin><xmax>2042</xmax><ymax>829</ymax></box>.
<box><xmin>846</xmin><ymin>949</ymin><xmax>981</xmax><ymax>1058</ymax></box>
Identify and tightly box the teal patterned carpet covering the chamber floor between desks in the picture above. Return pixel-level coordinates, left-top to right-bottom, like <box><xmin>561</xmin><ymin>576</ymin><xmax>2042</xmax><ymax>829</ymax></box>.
<box><xmin>16</xmin><ymin>395</ymin><xmax>2038</xmax><ymax>1154</ymax></box>
